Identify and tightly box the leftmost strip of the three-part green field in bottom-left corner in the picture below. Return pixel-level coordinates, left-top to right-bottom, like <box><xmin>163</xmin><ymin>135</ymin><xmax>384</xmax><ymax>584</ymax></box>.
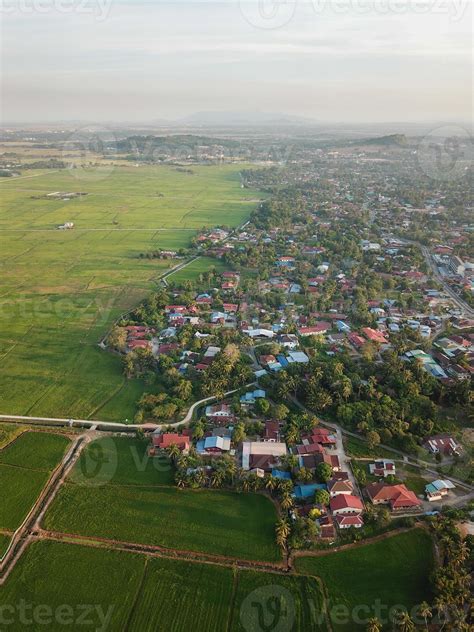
<box><xmin>0</xmin><ymin>541</ymin><xmax>144</xmax><ymax>632</ymax></box>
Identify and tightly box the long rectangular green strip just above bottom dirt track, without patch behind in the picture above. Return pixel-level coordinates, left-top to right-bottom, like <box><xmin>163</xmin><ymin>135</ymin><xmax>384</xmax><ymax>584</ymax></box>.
<box><xmin>44</xmin><ymin>483</ymin><xmax>280</xmax><ymax>561</ymax></box>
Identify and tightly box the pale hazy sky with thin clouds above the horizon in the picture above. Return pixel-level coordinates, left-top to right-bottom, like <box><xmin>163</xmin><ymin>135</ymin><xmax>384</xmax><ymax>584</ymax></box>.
<box><xmin>1</xmin><ymin>0</ymin><xmax>472</xmax><ymax>122</ymax></box>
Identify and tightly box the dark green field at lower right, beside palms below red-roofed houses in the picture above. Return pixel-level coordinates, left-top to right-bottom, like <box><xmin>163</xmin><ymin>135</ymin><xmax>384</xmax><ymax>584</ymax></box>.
<box><xmin>296</xmin><ymin>529</ymin><xmax>433</xmax><ymax>630</ymax></box>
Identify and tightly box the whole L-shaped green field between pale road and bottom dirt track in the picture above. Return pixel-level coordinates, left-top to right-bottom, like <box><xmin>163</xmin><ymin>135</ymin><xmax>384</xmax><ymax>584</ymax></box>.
<box><xmin>44</xmin><ymin>438</ymin><xmax>281</xmax><ymax>562</ymax></box>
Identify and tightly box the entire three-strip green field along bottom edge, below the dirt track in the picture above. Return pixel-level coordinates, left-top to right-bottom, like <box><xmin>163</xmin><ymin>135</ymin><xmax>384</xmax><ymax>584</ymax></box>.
<box><xmin>0</xmin><ymin>541</ymin><xmax>326</xmax><ymax>632</ymax></box>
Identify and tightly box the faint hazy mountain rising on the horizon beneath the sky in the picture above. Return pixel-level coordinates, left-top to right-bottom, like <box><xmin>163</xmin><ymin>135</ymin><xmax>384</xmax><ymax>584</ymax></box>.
<box><xmin>176</xmin><ymin>111</ymin><xmax>315</xmax><ymax>127</ymax></box>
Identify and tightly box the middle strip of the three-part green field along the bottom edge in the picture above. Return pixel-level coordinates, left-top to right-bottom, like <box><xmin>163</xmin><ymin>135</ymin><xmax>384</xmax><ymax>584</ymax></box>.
<box><xmin>127</xmin><ymin>558</ymin><xmax>232</xmax><ymax>632</ymax></box>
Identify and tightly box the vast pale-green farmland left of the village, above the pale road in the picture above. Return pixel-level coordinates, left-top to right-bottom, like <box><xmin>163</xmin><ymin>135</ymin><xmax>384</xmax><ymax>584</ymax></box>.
<box><xmin>0</xmin><ymin>166</ymin><xmax>256</xmax><ymax>421</ymax></box>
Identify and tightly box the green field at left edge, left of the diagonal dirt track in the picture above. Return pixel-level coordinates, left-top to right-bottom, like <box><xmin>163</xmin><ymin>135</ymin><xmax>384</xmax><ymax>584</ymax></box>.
<box><xmin>0</xmin><ymin>432</ymin><xmax>69</xmax><ymax>531</ymax></box>
